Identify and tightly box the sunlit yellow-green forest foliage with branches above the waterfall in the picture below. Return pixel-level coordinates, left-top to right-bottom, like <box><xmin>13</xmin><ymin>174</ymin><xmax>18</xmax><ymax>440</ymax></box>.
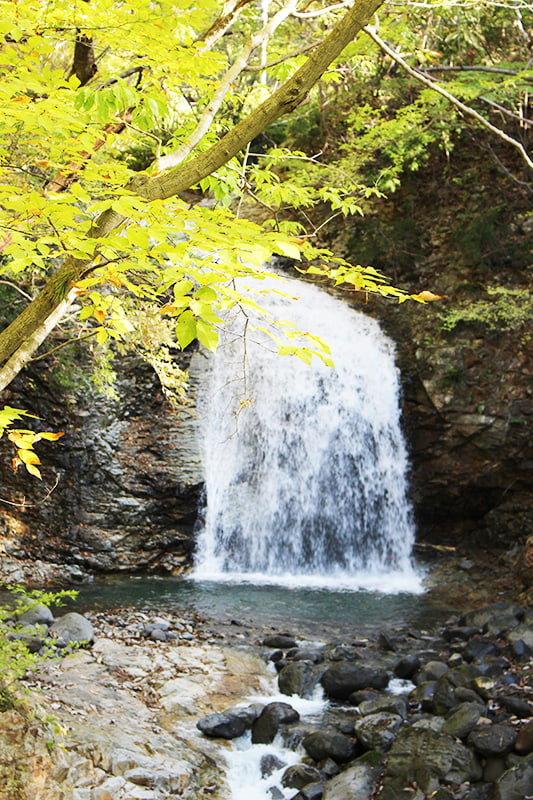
<box><xmin>0</xmin><ymin>0</ymin><xmax>533</xmax><ymax>472</ymax></box>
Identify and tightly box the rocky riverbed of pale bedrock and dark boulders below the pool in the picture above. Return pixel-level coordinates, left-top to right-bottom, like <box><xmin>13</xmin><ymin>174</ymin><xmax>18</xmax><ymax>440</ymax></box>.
<box><xmin>0</xmin><ymin>603</ymin><xmax>533</xmax><ymax>800</ymax></box>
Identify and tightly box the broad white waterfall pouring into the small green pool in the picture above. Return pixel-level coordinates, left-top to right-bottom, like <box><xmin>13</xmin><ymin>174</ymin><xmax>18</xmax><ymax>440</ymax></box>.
<box><xmin>195</xmin><ymin>272</ymin><xmax>417</xmax><ymax>590</ymax></box>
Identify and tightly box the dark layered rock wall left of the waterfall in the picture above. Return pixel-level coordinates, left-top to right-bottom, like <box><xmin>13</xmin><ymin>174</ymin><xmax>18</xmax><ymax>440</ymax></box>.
<box><xmin>0</xmin><ymin>357</ymin><xmax>202</xmax><ymax>574</ymax></box>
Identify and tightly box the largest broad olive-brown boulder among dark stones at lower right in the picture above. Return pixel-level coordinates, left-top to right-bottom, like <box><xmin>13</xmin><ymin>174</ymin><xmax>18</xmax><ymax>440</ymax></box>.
<box><xmin>387</xmin><ymin>727</ymin><xmax>481</xmax><ymax>783</ymax></box>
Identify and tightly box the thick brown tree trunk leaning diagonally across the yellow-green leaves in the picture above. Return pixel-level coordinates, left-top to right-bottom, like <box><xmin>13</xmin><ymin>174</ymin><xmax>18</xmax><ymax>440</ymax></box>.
<box><xmin>0</xmin><ymin>0</ymin><xmax>383</xmax><ymax>387</ymax></box>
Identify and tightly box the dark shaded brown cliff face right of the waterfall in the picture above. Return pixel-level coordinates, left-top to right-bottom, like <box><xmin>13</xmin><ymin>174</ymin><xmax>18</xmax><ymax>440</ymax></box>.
<box><xmin>329</xmin><ymin>147</ymin><xmax>533</xmax><ymax>548</ymax></box>
